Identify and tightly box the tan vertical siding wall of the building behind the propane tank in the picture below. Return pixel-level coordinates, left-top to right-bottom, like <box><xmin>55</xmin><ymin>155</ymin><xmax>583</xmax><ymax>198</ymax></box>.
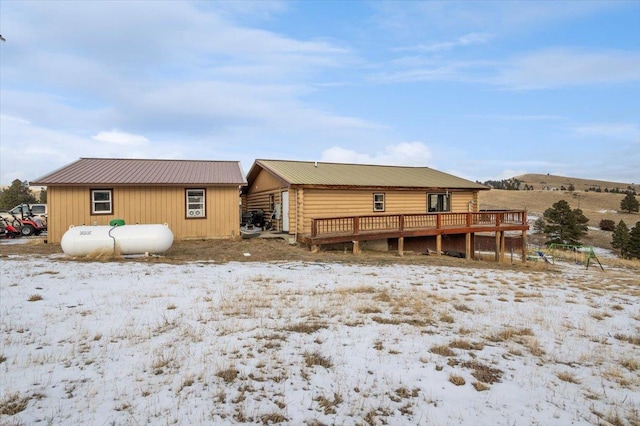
<box><xmin>47</xmin><ymin>186</ymin><xmax>240</xmax><ymax>243</ymax></box>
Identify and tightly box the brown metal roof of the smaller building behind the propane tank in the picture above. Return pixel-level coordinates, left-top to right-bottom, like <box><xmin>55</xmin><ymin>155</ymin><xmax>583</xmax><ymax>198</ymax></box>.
<box><xmin>32</xmin><ymin>158</ymin><xmax>246</xmax><ymax>186</ymax></box>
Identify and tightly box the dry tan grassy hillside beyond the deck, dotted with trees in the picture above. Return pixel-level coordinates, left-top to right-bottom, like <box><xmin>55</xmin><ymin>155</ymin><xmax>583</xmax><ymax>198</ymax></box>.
<box><xmin>479</xmin><ymin>174</ymin><xmax>640</xmax><ymax>249</ymax></box>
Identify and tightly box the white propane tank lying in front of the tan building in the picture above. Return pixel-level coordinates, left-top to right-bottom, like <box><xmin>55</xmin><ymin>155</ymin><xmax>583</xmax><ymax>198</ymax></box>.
<box><xmin>60</xmin><ymin>224</ymin><xmax>173</xmax><ymax>256</ymax></box>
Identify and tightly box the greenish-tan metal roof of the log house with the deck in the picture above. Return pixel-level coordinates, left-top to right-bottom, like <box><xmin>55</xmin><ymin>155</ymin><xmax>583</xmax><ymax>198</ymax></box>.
<box><xmin>247</xmin><ymin>160</ymin><xmax>489</xmax><ymax>190</ymax></box>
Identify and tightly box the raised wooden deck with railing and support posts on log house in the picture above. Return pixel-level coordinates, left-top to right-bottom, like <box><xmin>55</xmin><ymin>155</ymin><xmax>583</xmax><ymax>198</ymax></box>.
<box><xmin>298</xmin><ymin>210</ymin><xmax>529</xmax><ymax>258</ymax></box>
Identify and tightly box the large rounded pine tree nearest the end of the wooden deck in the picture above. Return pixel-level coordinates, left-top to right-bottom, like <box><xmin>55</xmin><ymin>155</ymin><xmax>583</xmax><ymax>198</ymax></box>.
<box><xmin>543</xmin><ymin>200</ymin><xmax>589</xmax><ymax>245</ymax></box>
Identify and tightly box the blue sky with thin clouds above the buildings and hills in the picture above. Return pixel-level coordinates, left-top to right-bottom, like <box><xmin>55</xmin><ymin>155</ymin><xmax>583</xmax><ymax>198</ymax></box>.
<box><xmin>0</xmin><ymin>0</ymin><xmax>640</xmax><ymax>185</ymax></box>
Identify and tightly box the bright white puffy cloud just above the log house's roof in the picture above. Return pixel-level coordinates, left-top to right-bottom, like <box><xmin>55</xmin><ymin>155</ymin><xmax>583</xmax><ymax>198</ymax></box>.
<box><xmin>322</xmin><ymin>142</ymin><xmax>432</xmax><ymax>166</ymax></box>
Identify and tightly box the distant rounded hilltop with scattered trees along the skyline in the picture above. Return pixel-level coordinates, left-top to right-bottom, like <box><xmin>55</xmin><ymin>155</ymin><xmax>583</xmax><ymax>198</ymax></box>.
<box><xmin>482</xmin><ymin>173</ymin><xmax>640</xmax><ymax>193</ymax></box>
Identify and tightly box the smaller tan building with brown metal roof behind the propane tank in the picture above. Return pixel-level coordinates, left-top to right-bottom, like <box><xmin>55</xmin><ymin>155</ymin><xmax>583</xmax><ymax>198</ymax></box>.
<box><xmin>32</xmin><ymin>158</ymin><xmax>246</xmax><ymax>243</ymax></box>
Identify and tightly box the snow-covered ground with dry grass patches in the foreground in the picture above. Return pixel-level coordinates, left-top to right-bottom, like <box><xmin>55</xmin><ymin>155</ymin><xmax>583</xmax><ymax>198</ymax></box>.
<box><xmin>0</xmin><ymin>256</ymin><xmax>640</xmax><ymax>425</ymax></box>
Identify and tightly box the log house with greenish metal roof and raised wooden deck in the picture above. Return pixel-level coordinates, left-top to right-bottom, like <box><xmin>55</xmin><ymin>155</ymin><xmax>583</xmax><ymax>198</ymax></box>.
<box><xmin>243</xmin><ymin>160</ymin><xmax>528</xmax><ymax>258</ymax></box>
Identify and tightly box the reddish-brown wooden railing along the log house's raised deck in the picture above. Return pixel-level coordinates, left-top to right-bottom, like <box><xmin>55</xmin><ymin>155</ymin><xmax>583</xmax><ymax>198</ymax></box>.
<box><xmin>311</xmin><ymin>210</ymin><xmax>527</xmax><ymax>237</ymax></box>
